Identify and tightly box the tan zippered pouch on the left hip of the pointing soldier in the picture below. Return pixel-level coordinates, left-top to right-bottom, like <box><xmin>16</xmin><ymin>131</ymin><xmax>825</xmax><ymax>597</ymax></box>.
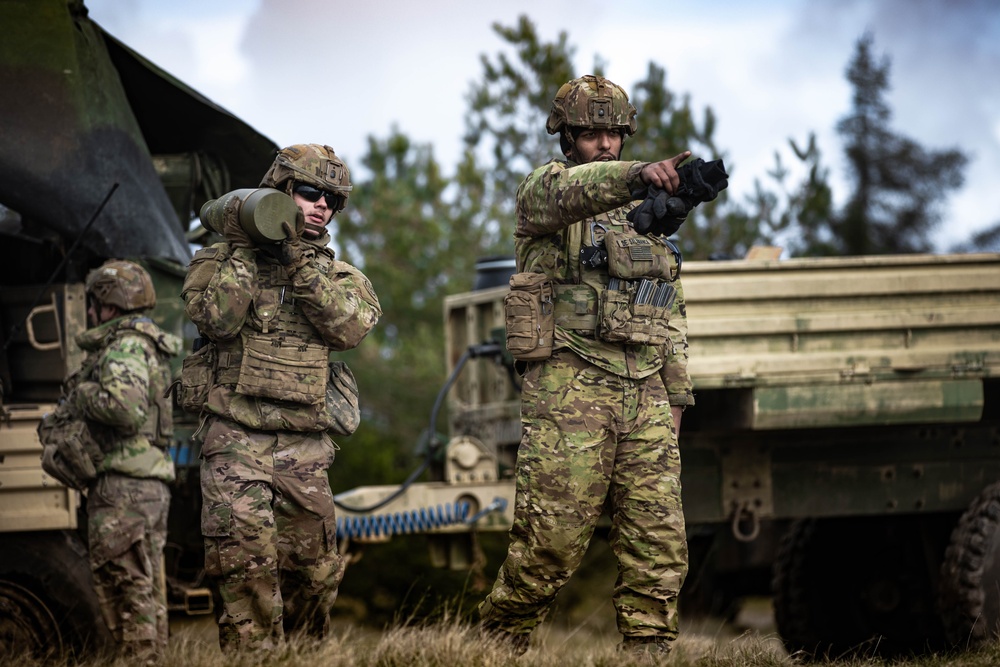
<box><xmin>503</xmin><ymin>273</ymin><xmax>556</xmax><ymax>361</ymax></box>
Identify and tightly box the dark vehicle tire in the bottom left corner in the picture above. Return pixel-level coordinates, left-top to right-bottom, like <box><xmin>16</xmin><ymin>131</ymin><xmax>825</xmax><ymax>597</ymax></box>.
<box><xmin>0</xmin><ymin>530</ymin><xmax>114</xmax><ymax>656</ymax></box>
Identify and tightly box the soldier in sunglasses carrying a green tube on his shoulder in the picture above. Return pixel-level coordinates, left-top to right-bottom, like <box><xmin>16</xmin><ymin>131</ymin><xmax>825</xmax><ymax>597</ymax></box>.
<box><xmin>182</xmin><ymin>144</ymin><xmax>381</xmax><ymax>651</ymax></box>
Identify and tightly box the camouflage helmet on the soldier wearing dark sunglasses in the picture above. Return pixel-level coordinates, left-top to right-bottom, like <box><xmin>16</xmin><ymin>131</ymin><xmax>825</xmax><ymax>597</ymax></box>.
<box><xmin>260</xmin><ymin>144</ymin><xmax>353</xmax><ymax>213</ymax></box>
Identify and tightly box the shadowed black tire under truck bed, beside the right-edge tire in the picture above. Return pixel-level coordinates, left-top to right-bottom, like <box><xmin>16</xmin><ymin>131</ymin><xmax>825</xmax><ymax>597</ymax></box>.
<box><xmin>773</xmin><ymin>516</ymin><xmax>943</xmax><ymax>658</ymax></box>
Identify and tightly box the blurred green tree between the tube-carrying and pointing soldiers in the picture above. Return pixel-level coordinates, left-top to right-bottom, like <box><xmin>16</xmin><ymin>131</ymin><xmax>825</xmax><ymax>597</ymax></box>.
<box><xmin>336</xmin><ymin>129</ymin><xmax>481</xmax><ymax>485</ymax></box>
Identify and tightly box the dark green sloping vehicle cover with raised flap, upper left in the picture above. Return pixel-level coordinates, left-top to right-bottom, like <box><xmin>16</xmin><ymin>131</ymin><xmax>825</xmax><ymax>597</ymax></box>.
<box><xmin>0</xmin><ymin>0</ymin><xmax>277</xmax><ymax>263</ymax></box>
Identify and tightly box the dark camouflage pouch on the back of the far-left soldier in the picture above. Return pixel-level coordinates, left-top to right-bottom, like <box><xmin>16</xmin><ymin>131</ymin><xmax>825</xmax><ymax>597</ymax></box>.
<box><xmin>38</xmin><ymin>401</ymin><xmax>104</xmax><ymax>491</ymax></box>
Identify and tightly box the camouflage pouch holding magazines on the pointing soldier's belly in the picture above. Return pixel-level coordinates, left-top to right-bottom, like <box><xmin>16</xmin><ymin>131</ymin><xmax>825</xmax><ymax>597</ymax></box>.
<box><xmin>597</xmin><ymin>278</ymin><xmax>676</xmax><ymax>345</ymax></box>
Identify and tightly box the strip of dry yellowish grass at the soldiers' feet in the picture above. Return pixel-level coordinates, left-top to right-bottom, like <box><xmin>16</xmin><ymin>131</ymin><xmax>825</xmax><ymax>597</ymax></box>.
<box><xmin>11</xmin><ymin>618</ymin><xmax>1000</xmax><ymax>667</ymax></box>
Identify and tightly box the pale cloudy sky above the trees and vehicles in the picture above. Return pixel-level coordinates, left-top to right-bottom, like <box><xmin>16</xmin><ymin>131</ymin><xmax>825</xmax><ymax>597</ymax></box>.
<box><xmin>86</xmin><ymin>0</ymin><xmax>1000</xmax><ymax>251</ymax></box>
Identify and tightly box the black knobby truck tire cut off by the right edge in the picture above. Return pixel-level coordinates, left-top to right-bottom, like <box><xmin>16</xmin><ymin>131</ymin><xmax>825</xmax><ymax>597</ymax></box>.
<box><xmin>938</xmin><ymin>482</ymin><xmax>1000</xmax><ymax>648</ymax></box>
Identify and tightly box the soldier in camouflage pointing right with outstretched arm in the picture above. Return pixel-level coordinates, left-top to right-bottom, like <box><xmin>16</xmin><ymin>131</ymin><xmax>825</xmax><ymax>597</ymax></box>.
<box><xmin>479</xmin><ymin>76</ymin><xmax>693</xmax><ymax>653</ymax></box>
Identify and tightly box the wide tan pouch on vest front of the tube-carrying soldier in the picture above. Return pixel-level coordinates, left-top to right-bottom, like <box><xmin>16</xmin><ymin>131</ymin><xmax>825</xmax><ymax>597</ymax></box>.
<box><xmin>236</xmin><ymin>335</ymin><xmax>329</xmax><ymax>405</ymax></box>
